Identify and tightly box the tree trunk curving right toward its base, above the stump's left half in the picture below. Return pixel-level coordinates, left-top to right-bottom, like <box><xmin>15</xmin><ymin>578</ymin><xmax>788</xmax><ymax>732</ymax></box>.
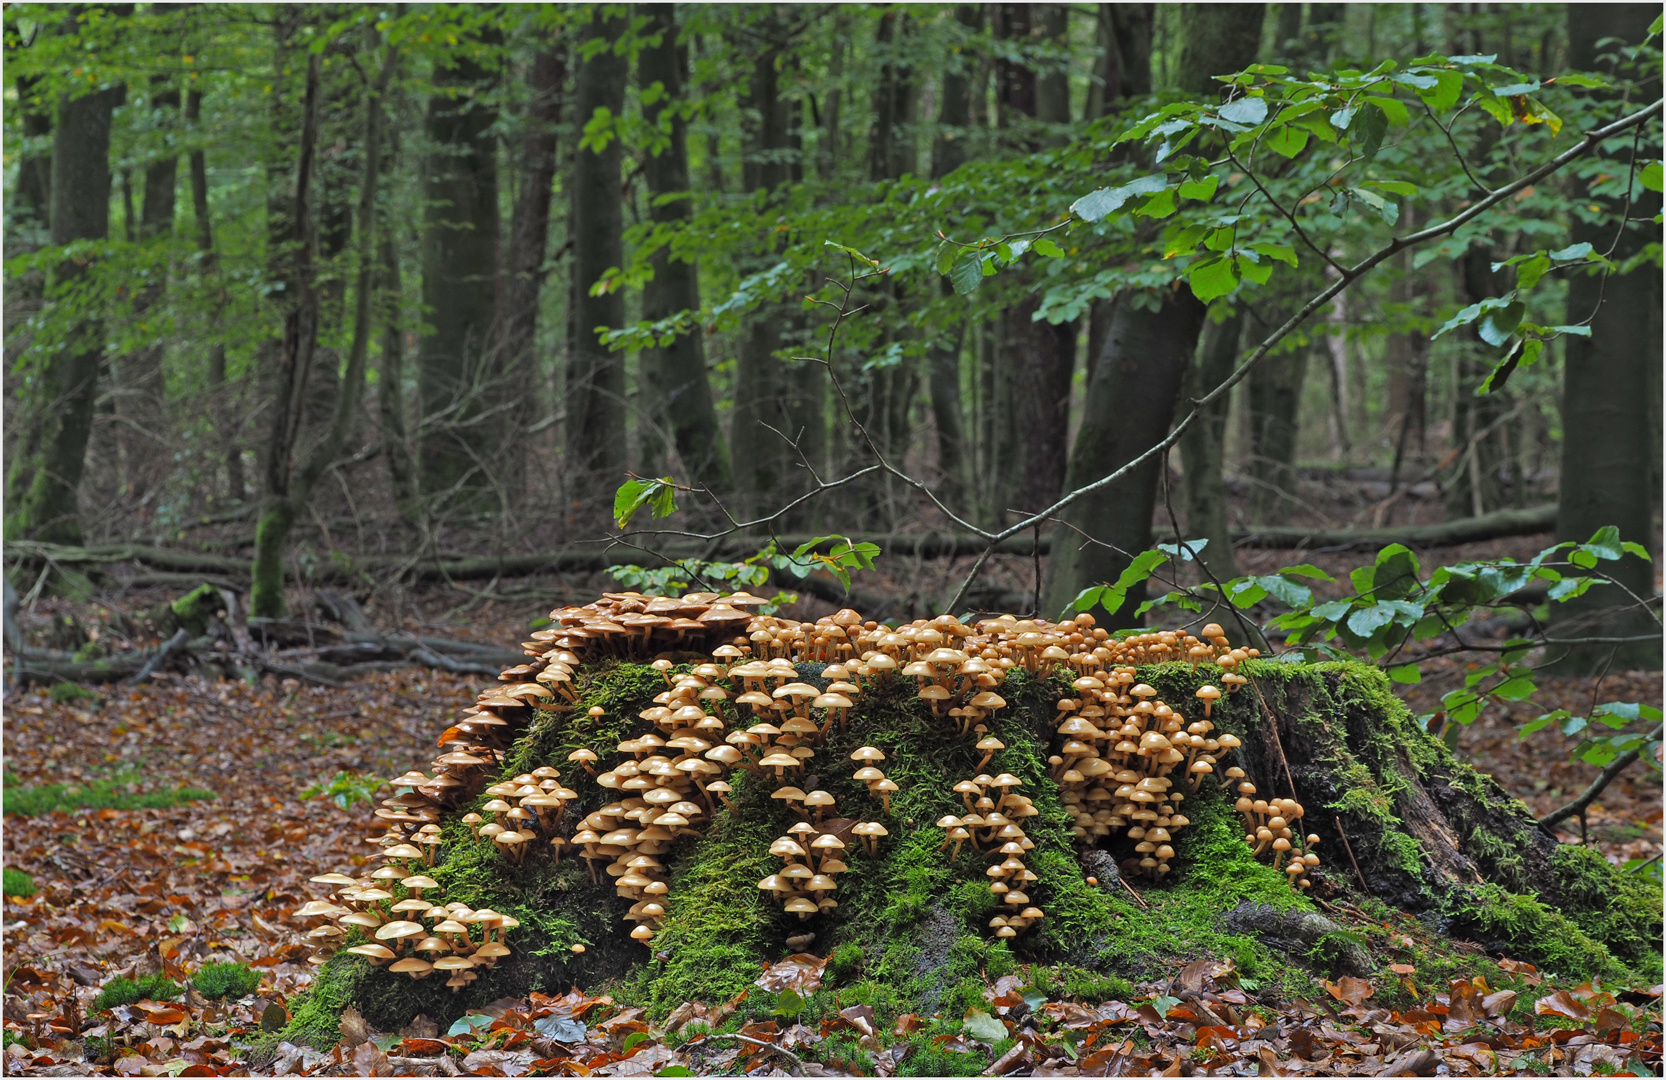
<box><xmin>636</xmin><ymin>3</ymin><xmax>730</xmax><ymax>492</ymax></box>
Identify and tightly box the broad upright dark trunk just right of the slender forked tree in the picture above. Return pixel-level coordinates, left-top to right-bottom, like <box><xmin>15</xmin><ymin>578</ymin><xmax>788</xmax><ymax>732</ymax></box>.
<box><xmin>417</xmin><ymin>46</ymin><xmax>499</xmax><ymax>510</ymax></box>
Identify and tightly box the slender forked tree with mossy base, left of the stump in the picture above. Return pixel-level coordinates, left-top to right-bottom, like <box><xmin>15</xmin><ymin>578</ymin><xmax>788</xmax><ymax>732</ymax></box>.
<box><xmin>250</xmin><ymin>47</ymin><xmax>398</xmax><ymax>617</ymax></box>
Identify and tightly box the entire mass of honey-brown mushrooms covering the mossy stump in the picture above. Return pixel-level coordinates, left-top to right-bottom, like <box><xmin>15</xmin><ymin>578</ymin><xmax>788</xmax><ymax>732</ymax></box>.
<box><xmin>297</xmin><ymin>593</ymin><xmax>1319</xmax><ymax>966</ymax></box>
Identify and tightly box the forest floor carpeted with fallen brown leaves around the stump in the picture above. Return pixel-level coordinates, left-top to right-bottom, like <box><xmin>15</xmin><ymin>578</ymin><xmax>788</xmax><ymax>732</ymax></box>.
<box><xmin>3</xmin><ymin>526</ymin><xmax>1661</xmax><ymax>1075</ymax></box>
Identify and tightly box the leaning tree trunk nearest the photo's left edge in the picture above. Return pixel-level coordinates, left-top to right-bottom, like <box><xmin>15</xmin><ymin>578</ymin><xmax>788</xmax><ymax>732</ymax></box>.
<box><xmin>5</xmin><ymin>64</ymin><xmax>123</xmax><ymax>543</ymax></box>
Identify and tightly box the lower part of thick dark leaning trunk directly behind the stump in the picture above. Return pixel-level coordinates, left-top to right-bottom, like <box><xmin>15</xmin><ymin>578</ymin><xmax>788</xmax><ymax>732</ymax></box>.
<box><xmin>1041</xmin><ymin>290</ymin><xmax>1205</xmax><ymax>627</ymax></box>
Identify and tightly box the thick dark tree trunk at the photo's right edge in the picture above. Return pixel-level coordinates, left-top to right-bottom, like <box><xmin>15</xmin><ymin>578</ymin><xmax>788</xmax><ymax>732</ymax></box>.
<box><xmin>1551</xmin><ymin>3</ymin><xmax>1661</xmax><ymax>672</ymax></box>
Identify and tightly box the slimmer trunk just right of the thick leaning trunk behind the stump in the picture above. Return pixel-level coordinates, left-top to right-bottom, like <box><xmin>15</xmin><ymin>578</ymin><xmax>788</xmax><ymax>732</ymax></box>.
<box><xmin>1180</xmin><ymin>308</ymin><xmax>1243</xmax><ymax>582</ymax></box>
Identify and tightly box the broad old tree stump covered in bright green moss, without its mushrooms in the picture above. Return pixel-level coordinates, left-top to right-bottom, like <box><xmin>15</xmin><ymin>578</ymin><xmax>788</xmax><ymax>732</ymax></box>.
<box><xmin>285</xmin><ymin>623</ymin><xmax>1661</xmax><ymax>1043</ymax></box>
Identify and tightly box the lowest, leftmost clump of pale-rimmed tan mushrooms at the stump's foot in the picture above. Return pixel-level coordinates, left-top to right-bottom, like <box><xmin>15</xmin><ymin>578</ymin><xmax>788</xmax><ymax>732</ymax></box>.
<box><xmin>293</xmin><ymin>840</ymin><xmax>520</xmax><ymax>993</ymax></box>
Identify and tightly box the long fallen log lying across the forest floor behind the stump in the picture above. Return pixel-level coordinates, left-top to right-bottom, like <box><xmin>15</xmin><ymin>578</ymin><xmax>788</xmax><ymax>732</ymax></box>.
<box><xmin>5</xmin><ymin>505</ymin><xmax>1556</xmax><ymax>595</ymax></box>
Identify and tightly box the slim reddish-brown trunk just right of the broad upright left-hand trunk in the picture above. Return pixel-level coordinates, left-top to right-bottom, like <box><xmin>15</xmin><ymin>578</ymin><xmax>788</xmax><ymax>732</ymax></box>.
<box><xmin>496</xmin><ymin>48</ymin><xmax>566</xmax><ymax>505</ymax></box>
